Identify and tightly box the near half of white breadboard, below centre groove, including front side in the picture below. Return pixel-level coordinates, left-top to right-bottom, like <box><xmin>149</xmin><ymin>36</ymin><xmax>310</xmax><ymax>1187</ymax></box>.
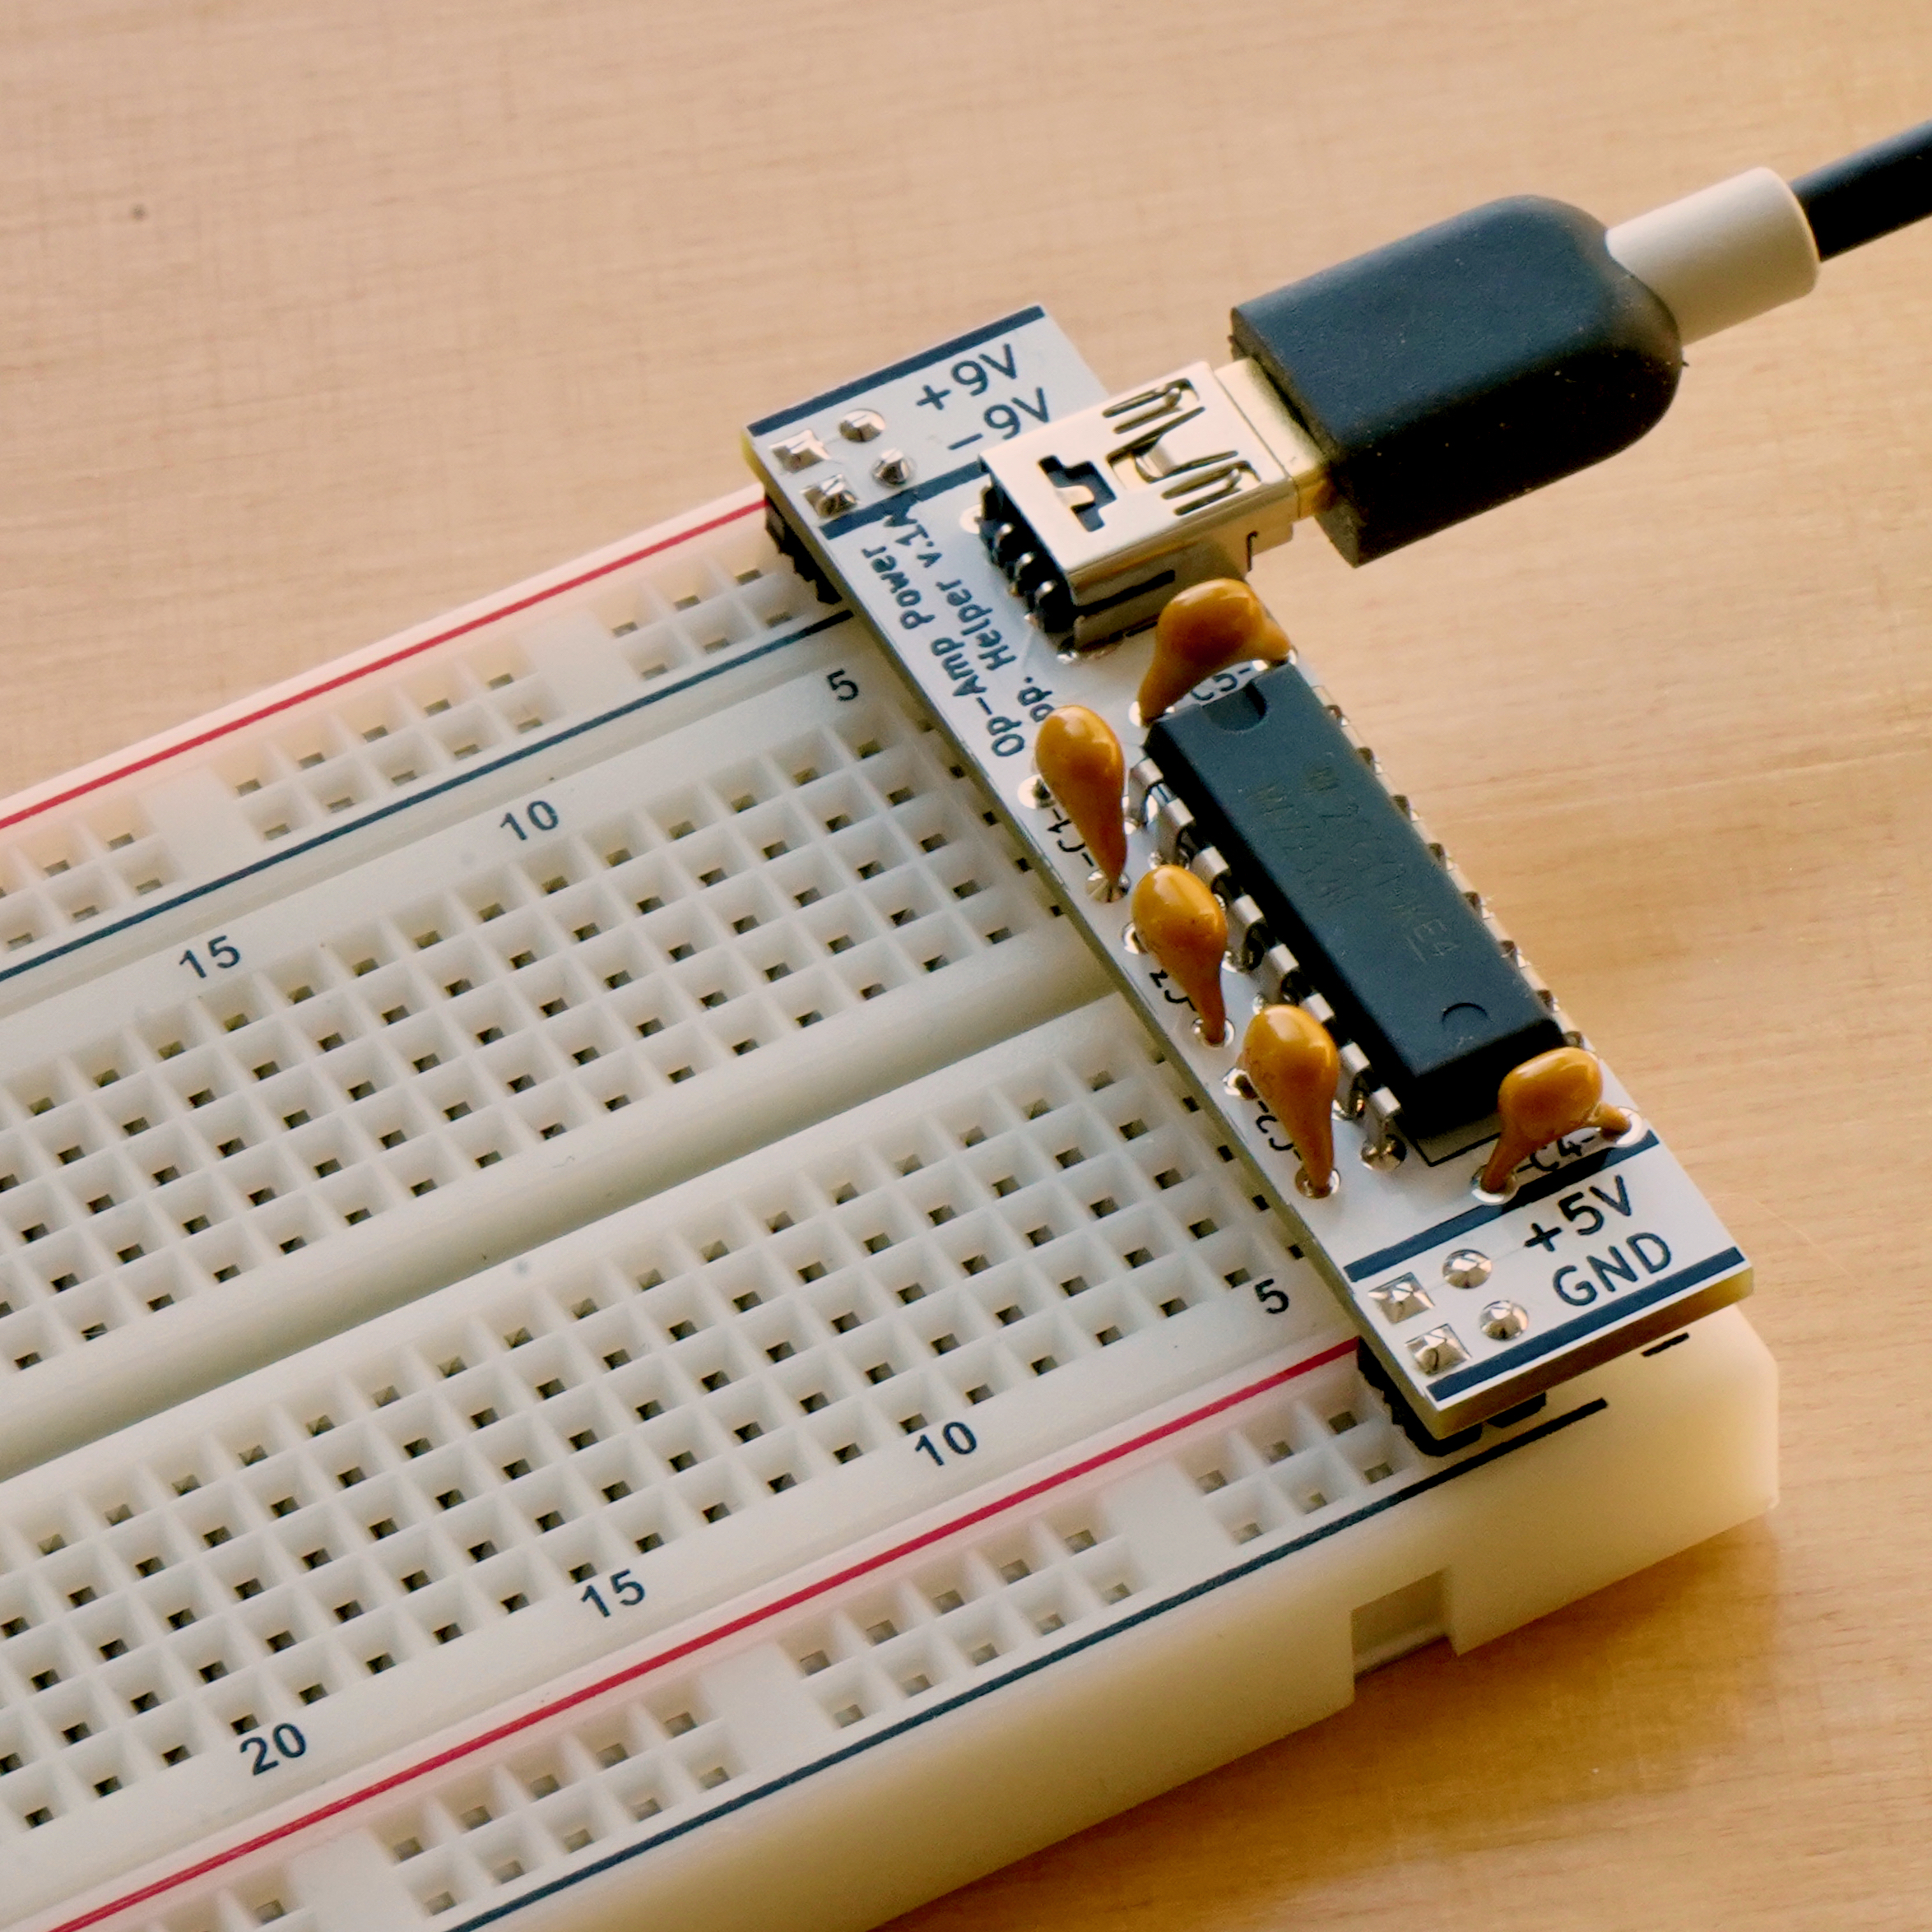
<box><xmin>0</xmin><ymin>999</ymin><xmax>1770</xmax><ymax>1932</ymax></box>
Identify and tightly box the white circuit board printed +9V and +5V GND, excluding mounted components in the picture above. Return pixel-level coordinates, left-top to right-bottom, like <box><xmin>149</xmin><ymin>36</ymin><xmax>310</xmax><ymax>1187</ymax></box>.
<box><xmin>745</xmin><ymin>309</ymin><xmax>1750</xmax><ymax>1436</ymax></box>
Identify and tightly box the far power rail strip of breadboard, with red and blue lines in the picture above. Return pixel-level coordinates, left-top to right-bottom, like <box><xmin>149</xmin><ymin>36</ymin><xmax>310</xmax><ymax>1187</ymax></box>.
<box><xmin>0</xmin><ymin>493</ymin><xmax>811</xmax><ymax>1005</ymax></box>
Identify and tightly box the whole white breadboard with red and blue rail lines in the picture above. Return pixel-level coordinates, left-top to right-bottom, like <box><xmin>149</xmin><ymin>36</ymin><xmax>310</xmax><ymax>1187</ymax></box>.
<box><xmin>0</xmin><ymin>486</ymin><xmax>1776</xmax><ymax>1932</ymax></box>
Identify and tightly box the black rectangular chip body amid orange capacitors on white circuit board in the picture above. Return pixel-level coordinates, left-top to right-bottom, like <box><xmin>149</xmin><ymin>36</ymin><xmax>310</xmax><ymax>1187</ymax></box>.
<box><xmin>1148</xmin><ymin>665</ymin><xmax>1563</xmax><ymax>1136</ymax></box>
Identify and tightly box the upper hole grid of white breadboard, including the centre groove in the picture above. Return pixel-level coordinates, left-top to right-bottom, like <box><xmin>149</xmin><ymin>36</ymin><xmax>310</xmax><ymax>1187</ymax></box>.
<box><xmin>0</xmin><ymin>506</ymin><xmax>1089</xmax><ymax>1470</ymax></box>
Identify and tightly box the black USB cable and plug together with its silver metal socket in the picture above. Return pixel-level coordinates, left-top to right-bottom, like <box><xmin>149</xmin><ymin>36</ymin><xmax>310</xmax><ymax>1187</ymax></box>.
<box><xmin>982</xmin><ymin>122</ymin><xmax>1932</xmax><ymax>649</ymax></box>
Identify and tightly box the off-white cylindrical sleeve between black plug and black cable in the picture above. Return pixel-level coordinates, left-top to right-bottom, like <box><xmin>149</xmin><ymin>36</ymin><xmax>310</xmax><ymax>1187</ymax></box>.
<box><xmin>1604</xmin><ymin>168</ymin><xmax>1818</xmax><ymax>342</ymax></box>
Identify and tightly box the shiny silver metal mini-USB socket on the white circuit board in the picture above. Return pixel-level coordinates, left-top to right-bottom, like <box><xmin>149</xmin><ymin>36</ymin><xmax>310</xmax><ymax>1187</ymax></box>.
<box><xmin>982</xmin><ymin>363</ymin><xmax>1323</xmax><ymax>649</ymax></box>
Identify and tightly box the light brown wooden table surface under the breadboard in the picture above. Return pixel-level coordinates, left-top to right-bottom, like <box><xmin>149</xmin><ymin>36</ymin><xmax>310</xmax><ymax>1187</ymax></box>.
<box><xmin>0</xmin><ymin>0</ymin><xmax>1932</xmax><ymax>1932</ymax></box>
